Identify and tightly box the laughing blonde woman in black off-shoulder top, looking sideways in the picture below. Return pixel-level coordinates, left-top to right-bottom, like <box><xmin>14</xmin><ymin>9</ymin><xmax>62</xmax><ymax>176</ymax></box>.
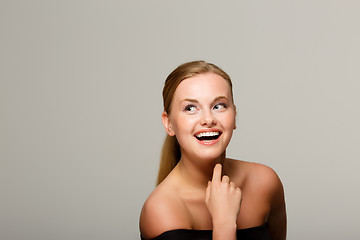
<box><xmin>140</xmin><ymin>61</ymin><xmax>286</xmax><ymax>240</ymax></box>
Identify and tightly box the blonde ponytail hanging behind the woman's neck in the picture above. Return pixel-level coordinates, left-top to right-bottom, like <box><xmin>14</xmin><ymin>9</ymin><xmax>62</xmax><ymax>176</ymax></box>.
<box><xmin>156</xmin><ymin>135</ymin><xmax>181</xmax><ymax>185</ymax></box>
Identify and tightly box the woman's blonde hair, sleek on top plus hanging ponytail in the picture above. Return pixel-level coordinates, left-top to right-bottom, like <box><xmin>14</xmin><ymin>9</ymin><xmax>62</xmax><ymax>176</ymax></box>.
<box><xmin>156</xmin><ymin>61</ymin><xmax>233</xmax><ymax>185</ymax></box>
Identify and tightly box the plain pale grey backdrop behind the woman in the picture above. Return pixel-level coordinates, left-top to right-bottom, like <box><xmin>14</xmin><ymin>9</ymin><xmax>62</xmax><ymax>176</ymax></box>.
<box><xmin>0</xmin><ymin>0</ymin><xmax>360</xmax><ymax>240</ymax></box>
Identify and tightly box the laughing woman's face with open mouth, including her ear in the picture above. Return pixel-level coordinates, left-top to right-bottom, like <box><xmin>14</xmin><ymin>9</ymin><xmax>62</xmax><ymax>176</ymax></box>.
<box><xmin>163</xmin><ymin>73</ymin><xmax>235</xmax><ymax>159</ymax></box>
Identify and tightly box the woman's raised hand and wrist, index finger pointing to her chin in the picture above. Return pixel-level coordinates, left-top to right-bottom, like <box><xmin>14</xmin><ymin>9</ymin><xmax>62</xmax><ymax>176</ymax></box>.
<box><xmin>205</xmin><ymin>164</ymin><xmax>241</xmax><ymax>239</ymax></box>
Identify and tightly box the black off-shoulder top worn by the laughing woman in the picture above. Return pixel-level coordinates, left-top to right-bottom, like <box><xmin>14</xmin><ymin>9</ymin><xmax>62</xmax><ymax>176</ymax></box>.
<box><xmin>141</xmin><ymin>224</ymin><xmax>271</xmax><ymax>240</ymax></box>
